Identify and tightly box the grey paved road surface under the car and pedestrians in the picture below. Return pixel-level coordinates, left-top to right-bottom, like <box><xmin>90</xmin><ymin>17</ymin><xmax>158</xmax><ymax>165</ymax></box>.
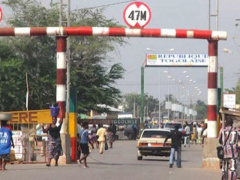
<box><xmin>0</xmin><ymin>141</ymin><xmax>221</xmax><ymax>180</ymax></box>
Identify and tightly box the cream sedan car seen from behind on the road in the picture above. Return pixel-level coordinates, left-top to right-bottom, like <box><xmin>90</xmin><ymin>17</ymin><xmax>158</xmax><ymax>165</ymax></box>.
<box><xmin>137</xmin><ymin>129</ymin><xmax>171</xmax><ymax>160</ymax></box>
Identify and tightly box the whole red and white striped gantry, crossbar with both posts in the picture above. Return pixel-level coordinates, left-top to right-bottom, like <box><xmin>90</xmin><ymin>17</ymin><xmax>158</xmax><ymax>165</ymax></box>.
<box><xmin>0</xmin><ymin>26</ymin><xmax>227</xmax><ymax>159</ymax></box>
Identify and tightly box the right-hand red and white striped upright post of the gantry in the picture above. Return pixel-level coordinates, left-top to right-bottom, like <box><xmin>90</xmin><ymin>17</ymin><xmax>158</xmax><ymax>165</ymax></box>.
<box><xmin>207</xmin><ymin>40</ymin><xmax>218</xmax><ymax>138</ymax></box>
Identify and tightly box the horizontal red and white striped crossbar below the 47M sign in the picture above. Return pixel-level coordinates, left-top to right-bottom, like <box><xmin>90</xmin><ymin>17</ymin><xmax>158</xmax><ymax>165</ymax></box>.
<box><xmin>0</xmin><ymin>27</ymin><xmax>227</xmax><ymax>40</ymax></box>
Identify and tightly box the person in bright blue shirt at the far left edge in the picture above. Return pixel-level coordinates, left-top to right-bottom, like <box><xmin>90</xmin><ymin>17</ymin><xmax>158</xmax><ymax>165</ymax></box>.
<box><xmin>0</xmin><ymin>121</ymin><xmax>14</xmax><ymax>171</ymax></box>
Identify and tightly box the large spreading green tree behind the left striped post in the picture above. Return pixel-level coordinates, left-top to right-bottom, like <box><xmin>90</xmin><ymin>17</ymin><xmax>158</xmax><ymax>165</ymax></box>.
<box><xmin>0</xmin><ymin>0</ymin><xmax>125</xmax><ymax>111</ymax></box>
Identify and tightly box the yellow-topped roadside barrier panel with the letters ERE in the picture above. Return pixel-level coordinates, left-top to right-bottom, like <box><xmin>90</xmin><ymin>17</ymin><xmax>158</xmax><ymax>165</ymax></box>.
<box><xmin>0</xmin><ymin>109</ymin><xmax>51</xmax><ymax>163</ymax></box>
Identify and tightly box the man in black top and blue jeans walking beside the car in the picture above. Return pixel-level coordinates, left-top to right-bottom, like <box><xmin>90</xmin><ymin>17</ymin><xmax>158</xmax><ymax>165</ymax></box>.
<box><xmin>164</xmin><ymin>126</ymin><xmax>191</xmax><ymax>168</ymax></box>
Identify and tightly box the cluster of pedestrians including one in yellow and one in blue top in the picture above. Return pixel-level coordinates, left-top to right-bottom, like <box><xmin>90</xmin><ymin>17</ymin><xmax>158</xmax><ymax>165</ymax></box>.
<box><xmin>77</xmin><ymin>122</ymin><xmax>116</xmax><ymax>168</ymax></box>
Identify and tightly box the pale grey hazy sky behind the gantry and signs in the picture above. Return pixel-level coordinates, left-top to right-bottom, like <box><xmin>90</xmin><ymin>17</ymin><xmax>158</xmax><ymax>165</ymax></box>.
<box><xmin>0</xmin><ymin>0</ymin><xmax>240</xmax><ymax>103</ymax></box>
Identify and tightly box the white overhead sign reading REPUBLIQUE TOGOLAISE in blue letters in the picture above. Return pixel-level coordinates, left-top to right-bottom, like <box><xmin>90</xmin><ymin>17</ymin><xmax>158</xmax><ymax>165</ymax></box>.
<box><xmin>146</xmin><ymin>54</ymin><xmax>208</xmax><ymax>67</ymax></box>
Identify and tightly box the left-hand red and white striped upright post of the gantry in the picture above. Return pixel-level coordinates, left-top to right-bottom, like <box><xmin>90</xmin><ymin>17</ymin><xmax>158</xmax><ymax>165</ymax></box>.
<box><xmin>56</xmin><ymin>36</ymin><xmax>68</xmax><ymax>133</ymax></box>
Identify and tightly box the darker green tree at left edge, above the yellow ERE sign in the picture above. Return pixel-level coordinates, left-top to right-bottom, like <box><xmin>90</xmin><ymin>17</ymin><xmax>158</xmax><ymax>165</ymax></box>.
<box><xmin>0</xmin><ymin>41</ymin><xmax>26</xmax><ymax>111</ymax></box>
